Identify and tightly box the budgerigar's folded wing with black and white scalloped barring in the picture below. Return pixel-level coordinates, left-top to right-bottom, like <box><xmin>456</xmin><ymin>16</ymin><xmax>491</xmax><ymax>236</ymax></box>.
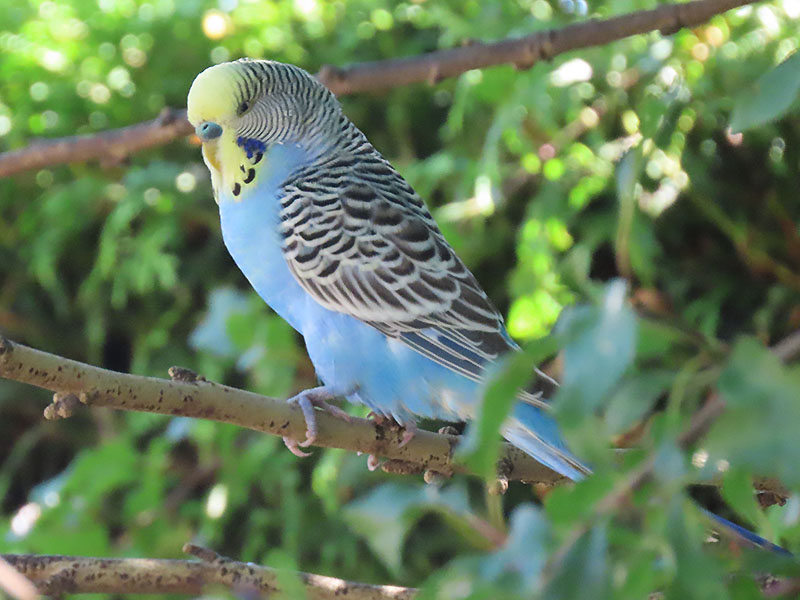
<box><xmin>280</xmin><ymin>137</ymin><xmax>541</xmax><ymax>404</ymax></box>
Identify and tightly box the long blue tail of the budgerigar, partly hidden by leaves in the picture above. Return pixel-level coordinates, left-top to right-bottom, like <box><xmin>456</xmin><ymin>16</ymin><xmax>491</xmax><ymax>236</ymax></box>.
<box><xmin>502</xmin><ymin>402</ymin><xmax>792</xmax><ymax>556</ymax></box>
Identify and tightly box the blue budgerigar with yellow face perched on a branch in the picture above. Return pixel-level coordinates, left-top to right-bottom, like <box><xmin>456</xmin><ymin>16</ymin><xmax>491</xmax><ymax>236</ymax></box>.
<box><xmin>188</xmin><ymin>60</ymin><xmax>792</xmax><ymax>548</ymax></box>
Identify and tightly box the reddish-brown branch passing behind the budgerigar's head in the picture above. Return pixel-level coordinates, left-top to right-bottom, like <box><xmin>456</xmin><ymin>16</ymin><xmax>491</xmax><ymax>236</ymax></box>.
<box><xmin>0</xmin><ymin>0</ymin><xmax>755</xmax><ymax>177</ymax></box>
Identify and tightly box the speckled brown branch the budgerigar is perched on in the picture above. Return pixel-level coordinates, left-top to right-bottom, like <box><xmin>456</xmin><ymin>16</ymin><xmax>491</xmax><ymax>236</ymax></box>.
<box><xmin>0</xmin><ymin>336</ymin><xmax>563</xmax><ymax>483</ymax></box>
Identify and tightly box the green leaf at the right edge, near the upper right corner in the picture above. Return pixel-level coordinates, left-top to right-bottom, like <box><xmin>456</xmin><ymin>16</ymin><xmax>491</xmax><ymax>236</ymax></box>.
<box><xmin>731</xmin><ymin>52</ymin><xmax>800</xmax><ymax>132</ymax></box>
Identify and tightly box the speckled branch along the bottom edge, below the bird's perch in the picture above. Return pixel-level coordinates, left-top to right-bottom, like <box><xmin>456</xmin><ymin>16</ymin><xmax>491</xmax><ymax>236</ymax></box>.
<box><xmin>0</xmin><ymin>544</ymin><xmax>417</xmax><ymax>600</ymax></box>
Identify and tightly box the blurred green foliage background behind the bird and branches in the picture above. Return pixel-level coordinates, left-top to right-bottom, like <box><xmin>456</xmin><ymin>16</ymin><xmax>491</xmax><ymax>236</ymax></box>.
<box><xmin>0</xmin><ymin>0</ymin><xmax>800</xmax><ymax>599</ymax></box>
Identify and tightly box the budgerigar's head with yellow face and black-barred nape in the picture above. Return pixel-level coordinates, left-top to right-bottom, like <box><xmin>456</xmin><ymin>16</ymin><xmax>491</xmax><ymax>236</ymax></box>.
<box><xmin>187</xmin><ymin>59</ymin><xmax>341</xmax><ymax>199</ymax></box>
